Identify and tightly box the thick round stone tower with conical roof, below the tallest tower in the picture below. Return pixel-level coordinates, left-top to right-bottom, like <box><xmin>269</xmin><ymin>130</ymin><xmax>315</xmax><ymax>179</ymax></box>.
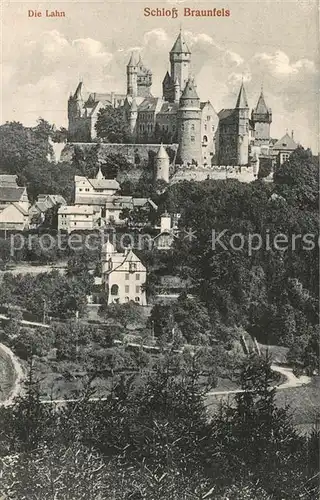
<box><xmin>177</xmin><ymin>78</ymin><xmax>202</xmax><ymax>164</ymax></box>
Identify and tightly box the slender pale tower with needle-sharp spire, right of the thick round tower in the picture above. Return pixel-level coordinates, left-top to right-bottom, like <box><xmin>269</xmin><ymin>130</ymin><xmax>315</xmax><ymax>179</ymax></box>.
<box><xmin>235</xmin><ymin>82</ymin><xmax>249</xmax><ymax>165</ymax></box>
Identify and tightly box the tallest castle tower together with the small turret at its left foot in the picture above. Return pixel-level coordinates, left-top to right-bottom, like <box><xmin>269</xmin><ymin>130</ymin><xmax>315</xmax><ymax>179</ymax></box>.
<box><xmin>162</xmin><ymin>31</ymin><xmax>191</xmax><ymax>102</ymax></box>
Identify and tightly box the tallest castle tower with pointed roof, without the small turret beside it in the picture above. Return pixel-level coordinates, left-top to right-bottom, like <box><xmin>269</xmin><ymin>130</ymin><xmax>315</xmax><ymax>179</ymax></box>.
<box><xmin>170</xmin><ymin>31</ymin><xmax>191</xmax><ymax>92</ymax></box>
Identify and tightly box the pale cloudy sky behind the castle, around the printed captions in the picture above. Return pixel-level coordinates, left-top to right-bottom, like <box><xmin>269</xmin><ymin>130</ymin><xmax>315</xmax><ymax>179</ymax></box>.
<box><xmin>1</xmin><ymin>0</ymin><xmax>319</xmax><ymax>153</ymax></box>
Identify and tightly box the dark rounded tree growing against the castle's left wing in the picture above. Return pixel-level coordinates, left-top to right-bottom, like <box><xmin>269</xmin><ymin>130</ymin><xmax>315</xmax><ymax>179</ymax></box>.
<box><xmin>95</xmin><ymin>106</ymin><xmax>131</xmax><ymax>143</ymax></box>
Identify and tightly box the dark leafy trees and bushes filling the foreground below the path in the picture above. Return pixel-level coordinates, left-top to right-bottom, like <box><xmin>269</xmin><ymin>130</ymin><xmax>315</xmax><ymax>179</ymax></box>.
<box><xmin>0</xmin><ymin>357</ymin><xmax>319</xmax><ymax>500</ymax></box>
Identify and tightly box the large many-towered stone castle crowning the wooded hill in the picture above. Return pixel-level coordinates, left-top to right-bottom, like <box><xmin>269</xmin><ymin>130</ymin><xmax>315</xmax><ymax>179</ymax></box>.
<box><xmin>68</xmin><ymin>32</ymin><xmax>272</xmax><ymax>171</ymax></box>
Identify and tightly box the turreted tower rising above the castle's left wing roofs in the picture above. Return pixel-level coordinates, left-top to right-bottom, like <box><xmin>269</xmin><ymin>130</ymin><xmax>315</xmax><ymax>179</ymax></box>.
<box><xmin>127</xmin><ymin>52</ymin><xmax>152</xmax><ymax>97</ymax></box>
